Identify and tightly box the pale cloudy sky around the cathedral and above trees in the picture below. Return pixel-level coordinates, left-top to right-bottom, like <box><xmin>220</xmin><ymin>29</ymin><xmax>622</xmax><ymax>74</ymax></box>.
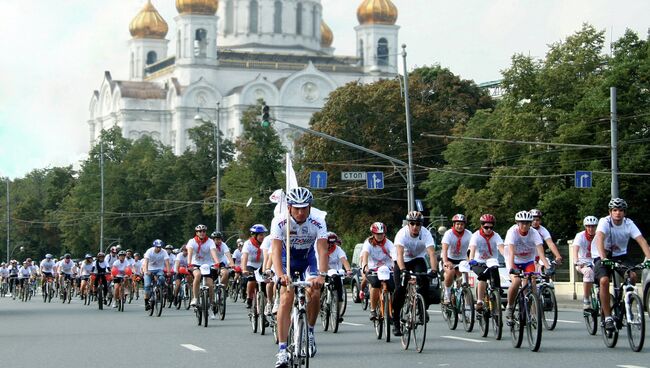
<box><xmin>0</xmin><ymin>0</ymin><xmax>650</xmax><ymax>179</ymax></box>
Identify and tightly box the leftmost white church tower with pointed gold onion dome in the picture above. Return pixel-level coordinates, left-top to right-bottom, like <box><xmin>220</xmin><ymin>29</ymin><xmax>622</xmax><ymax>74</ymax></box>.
<box><xmin>129</xmin><ymin>0</ymin><xmax>168</xmax><ymax>81</ymax></box>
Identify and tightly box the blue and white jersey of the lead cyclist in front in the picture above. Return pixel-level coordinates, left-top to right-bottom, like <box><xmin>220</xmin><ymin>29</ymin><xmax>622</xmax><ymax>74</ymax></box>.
<box><xmin>269</xmin><ymin>215</ymin><xmax>327</xmax><ymax>265</ymax></box>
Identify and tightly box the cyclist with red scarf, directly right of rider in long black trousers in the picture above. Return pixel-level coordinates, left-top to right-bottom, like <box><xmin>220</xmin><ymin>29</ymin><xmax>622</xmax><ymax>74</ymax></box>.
<box><xmin>440</xmin><ymin>213</ymin><xmax>472</xmax><ymax>304</ymax></box>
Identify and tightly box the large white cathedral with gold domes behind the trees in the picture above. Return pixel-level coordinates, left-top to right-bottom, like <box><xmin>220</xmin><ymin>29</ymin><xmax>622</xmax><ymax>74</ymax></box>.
<box><xmin>88</xmin><ymin>0</ymin><xmax>399</xmax><ymax>154</ymax></box>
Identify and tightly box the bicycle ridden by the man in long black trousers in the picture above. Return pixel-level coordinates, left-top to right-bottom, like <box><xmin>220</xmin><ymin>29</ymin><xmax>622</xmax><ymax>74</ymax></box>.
<box><xmin>400</xmin><ymin>270</ymin><xmax>429</xmax><ymax>353</ymax></box>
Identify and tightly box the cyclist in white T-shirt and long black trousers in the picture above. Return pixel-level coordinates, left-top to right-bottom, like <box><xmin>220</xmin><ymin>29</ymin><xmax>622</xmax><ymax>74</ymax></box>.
<box><xmin>393</xmin><ymin>211</ymin><xmax>438</xmax><ymax>336</ymax></box>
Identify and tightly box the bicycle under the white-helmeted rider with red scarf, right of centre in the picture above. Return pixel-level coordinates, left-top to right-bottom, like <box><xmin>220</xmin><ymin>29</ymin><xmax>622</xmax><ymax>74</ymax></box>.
<box><xmin>510</xmin><ymin>271</ymin><xmax>543</xmax><ymax>351</ymax></box>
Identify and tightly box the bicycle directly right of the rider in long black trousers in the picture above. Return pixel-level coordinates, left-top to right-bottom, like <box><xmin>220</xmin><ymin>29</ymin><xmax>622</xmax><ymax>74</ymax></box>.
<box><xmin>441</xmin><ymin>261</ymin><xmax>476</xmax><ymax>332</ymax></box>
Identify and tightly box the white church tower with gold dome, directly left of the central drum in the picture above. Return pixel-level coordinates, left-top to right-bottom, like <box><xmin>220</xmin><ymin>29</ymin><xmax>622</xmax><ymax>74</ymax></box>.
<box><xmin>174</xmin><ymin>0</ymin><xmax>219</xmax><ymax>65</ymax></box>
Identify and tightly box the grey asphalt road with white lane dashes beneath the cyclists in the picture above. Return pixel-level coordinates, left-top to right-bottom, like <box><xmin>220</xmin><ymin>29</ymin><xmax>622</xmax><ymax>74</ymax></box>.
<box><xmin>0</xmin><ymin>290</ymin><xmax>650</xmax><ymax>368</ymax></box>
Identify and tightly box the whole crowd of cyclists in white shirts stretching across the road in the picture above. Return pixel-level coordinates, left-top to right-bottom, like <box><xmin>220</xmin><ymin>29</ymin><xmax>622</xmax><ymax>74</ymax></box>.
<box><xmin>0</xmin><ymin>187</ymin><xmax>650</xmax><ymax>368</ymax></box>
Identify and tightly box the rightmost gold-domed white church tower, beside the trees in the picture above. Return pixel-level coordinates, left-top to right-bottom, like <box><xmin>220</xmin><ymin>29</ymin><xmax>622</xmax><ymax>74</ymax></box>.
<box><xmin>354</xmin><ymin>0</ymin><xmax>399</xmax><ymax>74</ymax></box>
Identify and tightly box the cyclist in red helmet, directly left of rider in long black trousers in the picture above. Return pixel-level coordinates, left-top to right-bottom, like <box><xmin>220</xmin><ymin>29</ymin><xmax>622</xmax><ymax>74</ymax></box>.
<box><xmin>360</xmin><ymin>222</ymin><xmax>395</xmax><ymax>321</ymax></box>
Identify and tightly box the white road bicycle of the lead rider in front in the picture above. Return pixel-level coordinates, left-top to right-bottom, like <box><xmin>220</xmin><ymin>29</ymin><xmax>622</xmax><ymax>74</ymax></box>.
<box><xmin>287</xmin><ymin>275</ymin><xmax>311</xmax><ymax>367</ymax></box>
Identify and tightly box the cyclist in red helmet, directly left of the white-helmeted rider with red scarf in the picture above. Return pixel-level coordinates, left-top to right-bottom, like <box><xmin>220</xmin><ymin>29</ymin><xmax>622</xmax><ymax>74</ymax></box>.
<box><xmin>469</xmin><ymin>213</ymin><xmax>504</xmax><ymax>311</ymax></box>
